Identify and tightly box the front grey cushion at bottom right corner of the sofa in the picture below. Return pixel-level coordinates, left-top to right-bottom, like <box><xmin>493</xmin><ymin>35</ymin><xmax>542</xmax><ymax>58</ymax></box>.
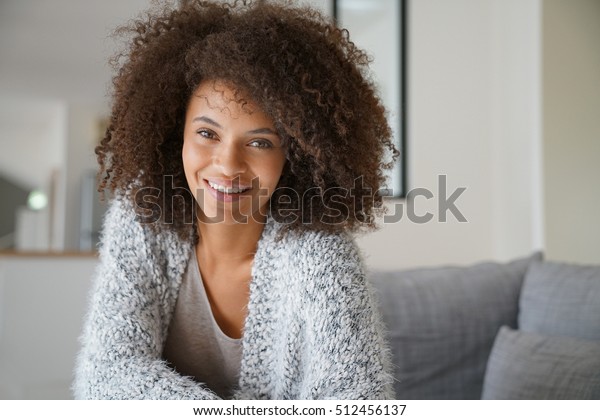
<box><xmin>482</xmin><ymin>327</ymin><xmax>600</xmax><ymax>400</ymax></box>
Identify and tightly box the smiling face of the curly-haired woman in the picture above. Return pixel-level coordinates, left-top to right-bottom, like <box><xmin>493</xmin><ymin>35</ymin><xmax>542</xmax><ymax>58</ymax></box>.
<box><xmin>182</xmin><ymin>80</ymin><xmax>285</xmax><ymax>223</ymax></box>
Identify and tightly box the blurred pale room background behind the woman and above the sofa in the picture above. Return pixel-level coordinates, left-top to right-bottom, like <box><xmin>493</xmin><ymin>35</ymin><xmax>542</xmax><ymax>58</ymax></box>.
<box><xmin>0</xmin><ymin>0</ymin><xmax>600</xmax><ymax>399</ymax></box>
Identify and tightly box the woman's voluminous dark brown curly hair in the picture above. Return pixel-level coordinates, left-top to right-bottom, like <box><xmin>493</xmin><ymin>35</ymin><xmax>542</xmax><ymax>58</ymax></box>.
<box><xmin>96</xmin><ymin>1</ymin><xmax>398</xmax><ymax>235</ymax></box>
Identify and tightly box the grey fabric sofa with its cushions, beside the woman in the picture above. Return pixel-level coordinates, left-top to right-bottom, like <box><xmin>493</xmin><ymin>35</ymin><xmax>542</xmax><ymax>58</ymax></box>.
<box><xmin>371</xmin><ymin>253</ymin><xmax>600</xmax><ymax>399</ymax></box>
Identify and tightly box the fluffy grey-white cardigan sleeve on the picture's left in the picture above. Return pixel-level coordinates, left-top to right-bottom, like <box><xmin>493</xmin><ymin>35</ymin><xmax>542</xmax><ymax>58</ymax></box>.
<box><xmin>73</xmin><ymin>199</ymin><xmax>217</xmax><ymax>399</ymax></box>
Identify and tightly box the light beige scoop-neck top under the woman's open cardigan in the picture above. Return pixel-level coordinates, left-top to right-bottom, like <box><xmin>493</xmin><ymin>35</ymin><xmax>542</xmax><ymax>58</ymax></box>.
<box><xmin>163</xmin><ymin>252</ymin><xmax>242</xmax><ymax>398</ymax></box>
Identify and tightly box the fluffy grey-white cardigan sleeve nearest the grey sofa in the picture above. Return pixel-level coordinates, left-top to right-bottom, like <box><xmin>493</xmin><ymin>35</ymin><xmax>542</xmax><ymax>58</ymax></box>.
<box><xmin>303</xmin><ymin>235</ymin><xmax>394</xmax><ymax>400</ymax></box>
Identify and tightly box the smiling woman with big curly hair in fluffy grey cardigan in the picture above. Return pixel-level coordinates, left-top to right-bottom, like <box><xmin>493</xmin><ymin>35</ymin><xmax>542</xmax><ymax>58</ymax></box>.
<box><xmin>73</xmin><ymin>2</ymin><xmax>396</xmax><ymax>399</ymax></box>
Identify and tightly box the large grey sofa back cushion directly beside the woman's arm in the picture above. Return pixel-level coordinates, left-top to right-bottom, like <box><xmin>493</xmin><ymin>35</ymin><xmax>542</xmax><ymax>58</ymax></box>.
<box><xmin>372</xmin><ymin>253</ymin><xmax>541</xmax><ymax>399</ymax></box>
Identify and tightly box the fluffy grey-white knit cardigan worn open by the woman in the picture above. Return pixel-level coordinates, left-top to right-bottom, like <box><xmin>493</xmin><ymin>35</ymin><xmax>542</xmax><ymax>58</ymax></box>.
<box><xmin>73</xmin><ymin>199</ymin><xmax>393</xmax><ymax>399</ymax></box>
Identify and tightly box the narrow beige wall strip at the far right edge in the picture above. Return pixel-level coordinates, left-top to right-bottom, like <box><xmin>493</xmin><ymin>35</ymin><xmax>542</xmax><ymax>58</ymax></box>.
<box><xmin>543</xmin><ymin>0</ymin><xmax>600</xmax><ymax>264</ymax></box>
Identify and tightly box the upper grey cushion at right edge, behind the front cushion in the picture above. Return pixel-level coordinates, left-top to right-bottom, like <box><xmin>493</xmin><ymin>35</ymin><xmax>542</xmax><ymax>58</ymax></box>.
<box><xmin>519</xmin><ymin>261</ymin><xmax>600</xmax><ymax>340</ymax></box>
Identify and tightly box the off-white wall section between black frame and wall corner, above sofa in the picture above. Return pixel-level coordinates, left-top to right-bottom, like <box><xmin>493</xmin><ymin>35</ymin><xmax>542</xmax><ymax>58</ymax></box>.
<box><xmin>358</xmin><ymin>0</ymin><xmax>543</xmax><ymax>269</ymax></box>
